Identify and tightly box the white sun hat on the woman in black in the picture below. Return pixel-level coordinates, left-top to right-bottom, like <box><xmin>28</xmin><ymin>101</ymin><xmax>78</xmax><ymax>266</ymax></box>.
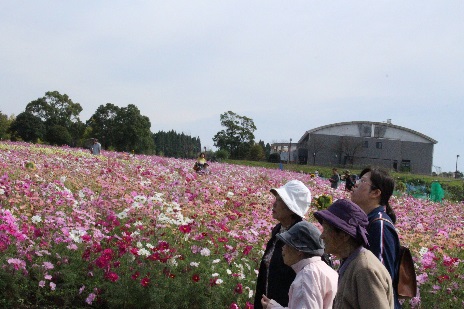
<box><xmin>271</xmin><ymin>180</ymin><xmax>311</xmax><ymax>218</ymax></box>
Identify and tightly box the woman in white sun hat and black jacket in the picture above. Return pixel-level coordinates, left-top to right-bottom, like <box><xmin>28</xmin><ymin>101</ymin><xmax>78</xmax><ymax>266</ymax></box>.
<box><xmin>254</xmin><ymin>180</ymin><xmax>311</xmax><ymax>309</ymax></box>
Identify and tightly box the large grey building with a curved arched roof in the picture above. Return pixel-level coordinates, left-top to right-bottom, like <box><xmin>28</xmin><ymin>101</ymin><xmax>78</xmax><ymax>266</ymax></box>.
<box><xmin>298</xmin><ymin>120</ymin><xmax>437</xmax><ymax>174</ymax></box>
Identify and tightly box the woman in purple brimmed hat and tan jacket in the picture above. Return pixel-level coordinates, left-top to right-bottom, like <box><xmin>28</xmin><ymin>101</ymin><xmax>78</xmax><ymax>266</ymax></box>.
<box><xmin>314</xmin><ymin>199</ymin><xmax>394</xmax><ymax>309</ymax></box>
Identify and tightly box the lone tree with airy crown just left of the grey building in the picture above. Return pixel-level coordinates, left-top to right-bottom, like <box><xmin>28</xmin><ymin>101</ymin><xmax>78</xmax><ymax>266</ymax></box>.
<box><xmin>213</xmin><ymin>111</ymin><xmax>256</xmax><ymax>159</ymax></box>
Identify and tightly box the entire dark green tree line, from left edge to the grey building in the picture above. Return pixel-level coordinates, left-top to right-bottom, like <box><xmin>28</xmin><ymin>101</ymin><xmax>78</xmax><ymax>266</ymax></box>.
<box><xmin>0</xmin><ymin>91</ymin><xmax>271</xmax><ymax>161</ymax></box>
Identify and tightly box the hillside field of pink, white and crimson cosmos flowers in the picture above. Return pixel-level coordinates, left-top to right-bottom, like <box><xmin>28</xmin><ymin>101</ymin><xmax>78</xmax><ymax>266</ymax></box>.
<box><xmin>0</xmin><ymin>142</ymin><xmax>464</xmax><ymax>308</ymax></box>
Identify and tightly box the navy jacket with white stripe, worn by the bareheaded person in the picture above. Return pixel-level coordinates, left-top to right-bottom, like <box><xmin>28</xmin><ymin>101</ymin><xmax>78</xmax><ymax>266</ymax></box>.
<box><xmin>367</xmin><ymin>206</ymin><xmax>401</xmax><ymax>308</ymax></box>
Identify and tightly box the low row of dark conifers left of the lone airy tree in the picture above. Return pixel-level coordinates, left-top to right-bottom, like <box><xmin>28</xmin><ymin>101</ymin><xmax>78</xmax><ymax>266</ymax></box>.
<box><xmin>153</xmin><ymin>130</ymin><xmax>201</xmax><ymax>158</ymax></box>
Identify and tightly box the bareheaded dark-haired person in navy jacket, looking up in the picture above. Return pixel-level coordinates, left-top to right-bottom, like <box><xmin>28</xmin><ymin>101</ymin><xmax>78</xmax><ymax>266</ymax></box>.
<box><xmin>351</xmin><ymin>168</ymin><xmax>401</xmax><ymax>308</ymax></box>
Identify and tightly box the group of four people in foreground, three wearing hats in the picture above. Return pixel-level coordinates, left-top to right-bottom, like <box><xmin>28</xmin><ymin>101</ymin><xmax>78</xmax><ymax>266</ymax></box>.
<box><xmin>254</xmin><ymin>168</ymin><xmax>401</xmax><ymax>309</ymax></box>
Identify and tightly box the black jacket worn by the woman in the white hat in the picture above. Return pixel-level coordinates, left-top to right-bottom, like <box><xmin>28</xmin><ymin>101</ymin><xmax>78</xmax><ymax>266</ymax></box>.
<box><xmin>254</xmin><ymin>220</ymin><xmax>301</xmax><ymax>309</ymax></box>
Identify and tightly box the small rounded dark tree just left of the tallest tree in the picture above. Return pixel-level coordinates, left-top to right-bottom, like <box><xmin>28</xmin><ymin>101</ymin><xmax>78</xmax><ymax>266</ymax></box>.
<box><xmin>9</xmin><ymin>112</ymin><xmax>46</xmax><ymax>143</ymax></box>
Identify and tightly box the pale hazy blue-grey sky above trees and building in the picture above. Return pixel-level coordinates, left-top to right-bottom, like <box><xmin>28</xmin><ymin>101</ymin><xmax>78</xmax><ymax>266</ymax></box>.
<box><xmin>0</xmin><ymin>0</ymin><xmax>464</xmax><ymax>172</ymax></box>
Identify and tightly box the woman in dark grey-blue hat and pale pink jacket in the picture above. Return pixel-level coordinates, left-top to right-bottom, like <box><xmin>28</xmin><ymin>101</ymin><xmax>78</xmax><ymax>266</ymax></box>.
<box><xmin>261</xmin><ymin>221</ymin><xmax>338</xmax><ymax>309</ymax></box>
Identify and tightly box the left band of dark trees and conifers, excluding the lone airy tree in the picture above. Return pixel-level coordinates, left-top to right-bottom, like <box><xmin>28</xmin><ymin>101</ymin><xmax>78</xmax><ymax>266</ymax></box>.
<box><xmin>0</xmin><ymin>91</ymin><xmax>201</xmax><ymax>157</ymax></box>
